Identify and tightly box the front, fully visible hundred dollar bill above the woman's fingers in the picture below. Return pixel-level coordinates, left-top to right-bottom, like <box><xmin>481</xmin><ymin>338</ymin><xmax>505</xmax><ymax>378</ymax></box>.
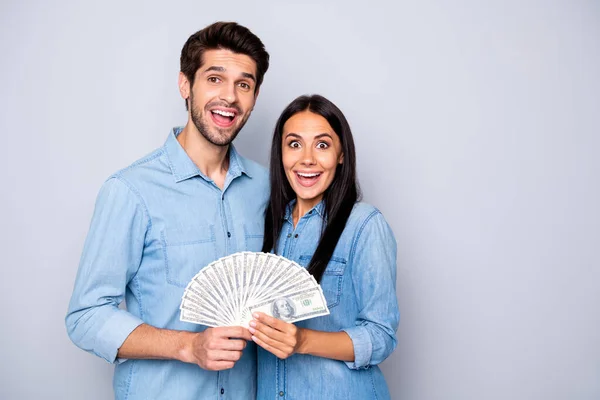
<box><xmin>240</xmin><ymin>287</ymin><xmax>329</xmax><ymax>326</ymax></box>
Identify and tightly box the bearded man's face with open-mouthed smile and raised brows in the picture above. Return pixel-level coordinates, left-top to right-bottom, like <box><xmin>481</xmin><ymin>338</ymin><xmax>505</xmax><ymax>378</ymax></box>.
<box><xmin>180</xmin><ymin>50</ymin><xmax>258</xmax><ymax>146</ymax></box>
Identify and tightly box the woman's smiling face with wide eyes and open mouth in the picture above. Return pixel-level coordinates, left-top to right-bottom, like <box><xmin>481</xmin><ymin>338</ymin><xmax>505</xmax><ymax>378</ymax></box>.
<box><xmin>281</xmin><ymin>111</ymin><xmax>344</xmax><ymax>208</ymax></box>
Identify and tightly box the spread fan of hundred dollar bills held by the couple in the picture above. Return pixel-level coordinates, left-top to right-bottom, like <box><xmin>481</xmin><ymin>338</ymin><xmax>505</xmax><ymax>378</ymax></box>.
<box><xmin>179</xmin><ymin>252</ymin><xmax>329</xmax><ymax>327</ymax></box>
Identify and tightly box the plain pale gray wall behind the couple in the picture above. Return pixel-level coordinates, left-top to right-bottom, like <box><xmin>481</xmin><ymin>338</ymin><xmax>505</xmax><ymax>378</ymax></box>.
<box><xmin>0</xmin><ymin>0</ymin><xmax>600</xmax><ymax>400</ymax></box>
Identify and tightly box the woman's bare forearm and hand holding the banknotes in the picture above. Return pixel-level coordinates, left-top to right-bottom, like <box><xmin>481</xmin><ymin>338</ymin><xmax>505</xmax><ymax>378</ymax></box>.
<box><xmin>250</xmin><ymin>313</ymin><xmax>354</xmax><ymax>362</ymax></box>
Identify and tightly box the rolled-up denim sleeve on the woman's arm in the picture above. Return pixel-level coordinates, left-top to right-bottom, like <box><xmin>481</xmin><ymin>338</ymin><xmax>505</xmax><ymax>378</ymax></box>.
<box><xmin>343</xmin><ymin>211</ymin><xmax>400</xmax><ymax>369</ymax></box>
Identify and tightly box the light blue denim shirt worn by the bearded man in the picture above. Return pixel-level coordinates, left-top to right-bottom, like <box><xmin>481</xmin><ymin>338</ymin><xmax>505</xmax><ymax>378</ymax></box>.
<box><xmin>66</xmin><ymin>128</ymin><xmax>268</xmax><ymax>400</ymax></box>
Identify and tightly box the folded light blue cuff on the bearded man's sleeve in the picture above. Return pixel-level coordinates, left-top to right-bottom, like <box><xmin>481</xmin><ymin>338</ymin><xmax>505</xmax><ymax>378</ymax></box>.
<box><xmin>94</xmin><ymin>310</ymin><xmax>144</xmax><ymax>364</ymax></box>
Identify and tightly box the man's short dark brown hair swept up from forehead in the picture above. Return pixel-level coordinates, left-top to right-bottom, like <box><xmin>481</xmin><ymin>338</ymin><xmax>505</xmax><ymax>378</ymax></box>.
<box><xmin>180</xmin><ymin>22</ymin><xmax>269</xmax><ymax>109</ymax></box>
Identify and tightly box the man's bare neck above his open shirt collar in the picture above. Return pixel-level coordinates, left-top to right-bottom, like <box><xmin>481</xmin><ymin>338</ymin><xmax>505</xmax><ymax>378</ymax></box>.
<box><xmin>177</xmin><ymin>121</ymin><xmax>229</xmax><ymax>189</ymax></box>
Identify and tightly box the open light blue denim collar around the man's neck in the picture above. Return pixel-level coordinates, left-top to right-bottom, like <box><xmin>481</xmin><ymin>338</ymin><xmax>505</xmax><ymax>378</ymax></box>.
<box><xmin>164</xmin><ymin>126</ymin><xmax>252</xmax><ymax>182</ymax></box>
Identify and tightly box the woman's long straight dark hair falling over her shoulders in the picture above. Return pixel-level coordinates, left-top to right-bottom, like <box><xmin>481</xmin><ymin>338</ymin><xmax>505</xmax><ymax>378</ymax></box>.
<box><xmin>262</xmin><ymin>94</ymin><xmax>360</xmax><ymax>282</ymax></box>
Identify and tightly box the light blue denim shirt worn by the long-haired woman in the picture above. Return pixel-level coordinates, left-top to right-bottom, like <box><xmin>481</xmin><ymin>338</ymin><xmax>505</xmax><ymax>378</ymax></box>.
<box><xmin>258</xmin><ymin>202</ymin><xmax>400</xmax><ymax>400</ymax></box>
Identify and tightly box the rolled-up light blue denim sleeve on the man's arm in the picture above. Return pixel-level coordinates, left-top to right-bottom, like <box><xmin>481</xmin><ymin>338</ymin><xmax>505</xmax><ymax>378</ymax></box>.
<box><xmin>65</xmin><ymin>177</ymin><xmax>150</xmax><ymax>363</ymax></box>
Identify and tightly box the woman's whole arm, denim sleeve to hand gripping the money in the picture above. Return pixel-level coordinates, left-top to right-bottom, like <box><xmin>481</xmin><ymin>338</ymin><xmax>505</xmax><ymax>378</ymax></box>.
<box><xmin>250</xmin><ymin>210</ymin><xmax>400</xmax><ymax>369</ymax></box>
